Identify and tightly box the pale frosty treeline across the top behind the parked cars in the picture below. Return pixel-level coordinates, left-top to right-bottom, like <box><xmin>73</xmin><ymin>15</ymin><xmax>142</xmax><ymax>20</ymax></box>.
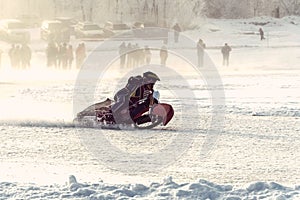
<box><xmin>0</xmin><ymin>0</ymin><xmax>300</xmax><ymax>25</ymax></box>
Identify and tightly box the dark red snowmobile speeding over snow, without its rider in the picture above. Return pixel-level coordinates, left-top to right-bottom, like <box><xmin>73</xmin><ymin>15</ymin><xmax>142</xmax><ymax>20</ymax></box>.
<box><xmin>74</xmin><ymin>98</ymin><xmax>174</xmax><ymax>129</ymax></box>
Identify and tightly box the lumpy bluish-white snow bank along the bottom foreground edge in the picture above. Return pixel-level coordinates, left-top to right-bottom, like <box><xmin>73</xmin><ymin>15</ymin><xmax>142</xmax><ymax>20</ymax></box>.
<box><xmin>0</xmin><ymin>175</ymin><xmax>300</xmax><ymax>200</ymax></box>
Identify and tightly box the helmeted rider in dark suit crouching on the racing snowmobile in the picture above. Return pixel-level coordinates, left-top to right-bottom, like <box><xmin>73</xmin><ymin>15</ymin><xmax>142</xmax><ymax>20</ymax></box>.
<box><xmin>112</xmin><ymin>71</ymin><xmax>160</xmax><ymax>124</ymax></box>
